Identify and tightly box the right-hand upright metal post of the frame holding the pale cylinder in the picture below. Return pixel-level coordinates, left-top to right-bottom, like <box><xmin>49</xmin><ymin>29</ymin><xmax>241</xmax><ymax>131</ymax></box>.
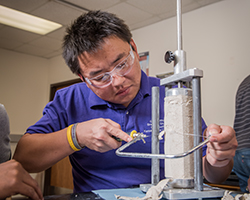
<box><xmin>192</xmin><ymin>77</ymin><xmax>203</xmax><ymax>191</ymax></box>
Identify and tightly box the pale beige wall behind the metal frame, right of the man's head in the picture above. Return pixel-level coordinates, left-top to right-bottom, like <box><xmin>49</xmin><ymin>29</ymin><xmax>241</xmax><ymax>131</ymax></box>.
<box><xmin>133</xmin><ymin>0</ymin><xmax>250</xmax><ymax>125</ymax></box>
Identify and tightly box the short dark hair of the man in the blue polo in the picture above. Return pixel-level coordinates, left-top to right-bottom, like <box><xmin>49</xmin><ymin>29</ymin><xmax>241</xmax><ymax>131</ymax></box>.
<box><xmin>63</xmin><ymin>11</ymin><xmax>132</xmax><ymax>74</ymax></box>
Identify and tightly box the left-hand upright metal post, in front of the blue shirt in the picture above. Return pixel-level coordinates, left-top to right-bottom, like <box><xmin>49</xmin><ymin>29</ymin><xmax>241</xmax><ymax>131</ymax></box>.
<box><xmin>151</xmin><ymin>87</ymin><xmax>160</xmax><ymax>185</ymax></box>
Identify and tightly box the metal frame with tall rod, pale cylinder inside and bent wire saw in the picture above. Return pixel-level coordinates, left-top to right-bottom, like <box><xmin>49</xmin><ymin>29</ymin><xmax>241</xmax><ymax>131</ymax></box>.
<box><xmin>116</xmin><ymin>0</ymin><xmax>224</xmax><ymax>199</ymax></box>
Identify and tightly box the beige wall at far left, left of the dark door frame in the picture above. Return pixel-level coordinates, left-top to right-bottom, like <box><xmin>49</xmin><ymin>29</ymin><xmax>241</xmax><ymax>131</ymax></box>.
<box><xmin>0</xmin><ymin>49</ymin><xmax>49</xmax><ymax>134</ymax></box>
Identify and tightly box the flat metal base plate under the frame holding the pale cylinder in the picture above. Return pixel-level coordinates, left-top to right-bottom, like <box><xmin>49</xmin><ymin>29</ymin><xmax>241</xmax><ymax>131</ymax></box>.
<box><xmin>140</xmin><ymin>184</ymin><xmax>225</xmax><ymax>199</ymax></box>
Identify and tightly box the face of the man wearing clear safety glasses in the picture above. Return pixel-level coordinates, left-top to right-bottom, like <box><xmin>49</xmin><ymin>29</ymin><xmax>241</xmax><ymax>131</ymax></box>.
<box><xmin>78</xmin><ymin>37</ymin><xmax>141</xmax><ymax>107</ymax></box>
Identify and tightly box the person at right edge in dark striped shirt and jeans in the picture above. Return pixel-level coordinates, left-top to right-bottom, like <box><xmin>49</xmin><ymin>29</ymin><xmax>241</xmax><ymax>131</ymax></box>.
<box><xmin>233</xmin><ymin>75</ymin><xmax>250</xmax><ymax>192</ymax></box>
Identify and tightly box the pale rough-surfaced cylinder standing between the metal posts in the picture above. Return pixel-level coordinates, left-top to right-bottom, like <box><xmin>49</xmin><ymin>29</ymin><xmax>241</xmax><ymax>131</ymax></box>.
<box><xmin>164</xmin><ymin>88</ymin><xmax>194</xmax><ymax>184</ymax></box>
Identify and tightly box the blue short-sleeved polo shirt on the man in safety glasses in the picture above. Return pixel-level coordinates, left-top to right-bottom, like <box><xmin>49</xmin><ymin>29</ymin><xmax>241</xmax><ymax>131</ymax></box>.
<box><xmin>26</xmin><ymin>72</ymin><xmax>206</xmax><ymax>192</ymax></box>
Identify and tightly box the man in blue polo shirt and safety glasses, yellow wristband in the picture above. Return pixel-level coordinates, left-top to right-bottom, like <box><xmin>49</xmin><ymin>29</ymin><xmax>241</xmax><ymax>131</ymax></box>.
<box><xmin>14</xmin><ymin>11</ymin><xmax>237</xmax><ymax>192</ymax></box>
